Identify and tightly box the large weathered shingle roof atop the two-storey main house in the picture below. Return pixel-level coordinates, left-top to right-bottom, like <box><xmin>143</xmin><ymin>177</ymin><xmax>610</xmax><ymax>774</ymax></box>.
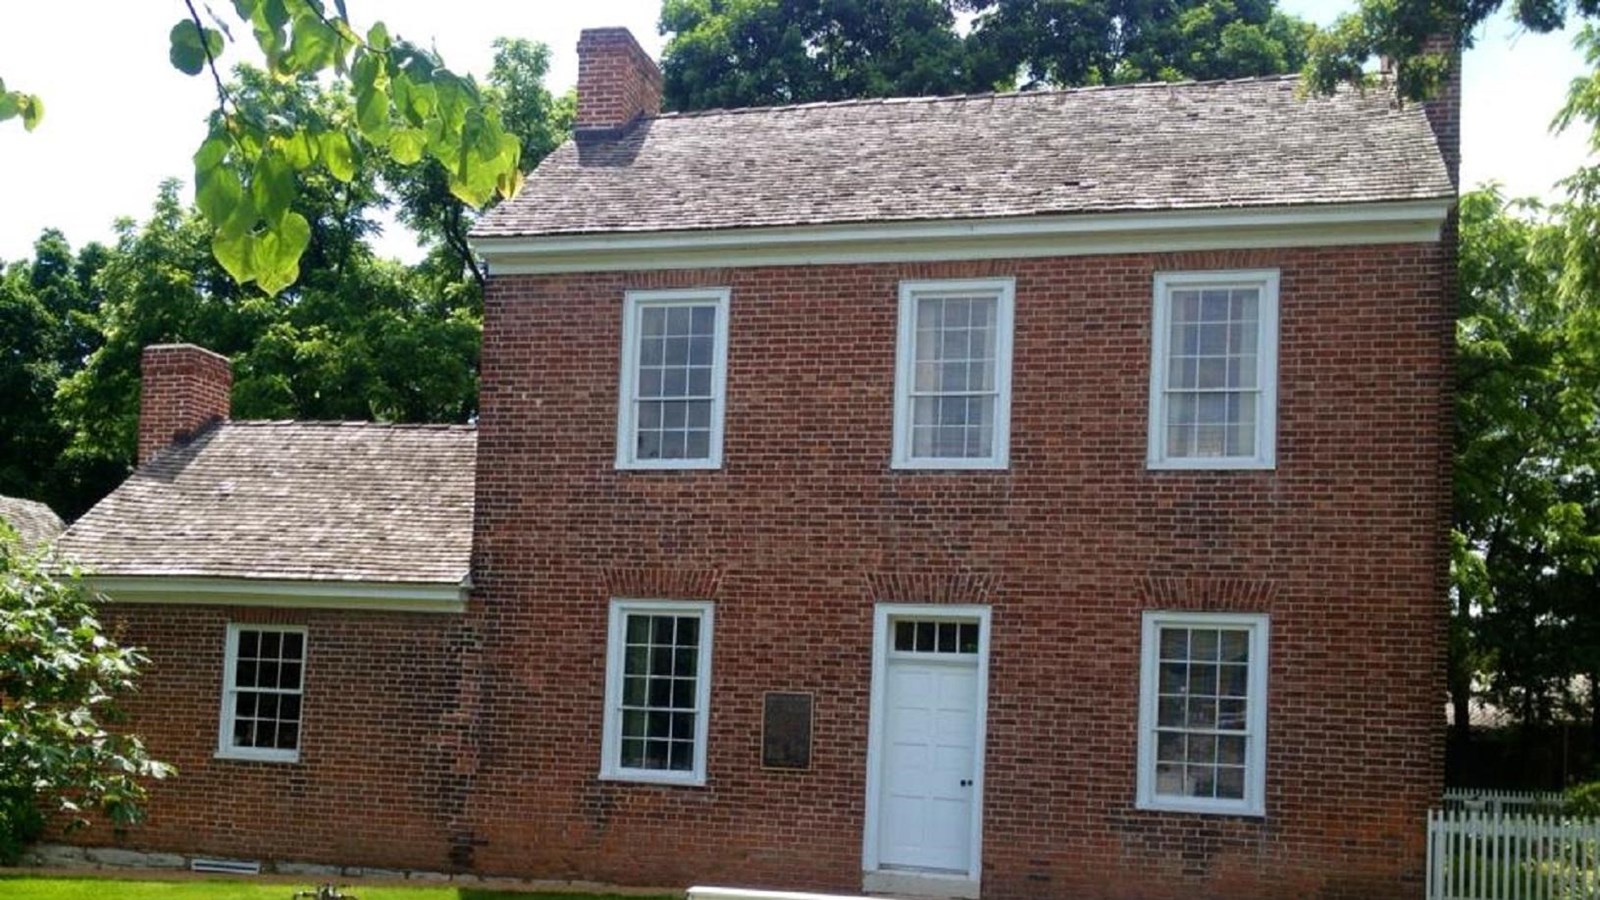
<box><xmin>474</xmin><ymin>77</ymin><xmax>1453</xmax><ymax>237</ymax></box>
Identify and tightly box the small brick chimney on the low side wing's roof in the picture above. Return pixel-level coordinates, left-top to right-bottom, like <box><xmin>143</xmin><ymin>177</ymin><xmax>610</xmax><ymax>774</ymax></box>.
<box><xmin>139</xmin><ymin>344</ymin><xmax>234</xmax><ymax>466</ymax></box>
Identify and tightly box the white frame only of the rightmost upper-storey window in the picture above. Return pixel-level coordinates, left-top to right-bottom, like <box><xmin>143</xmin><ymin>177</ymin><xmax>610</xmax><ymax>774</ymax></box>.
<box><xmin>1147</xmin><ymin>269</ymin><xmax>1278</xmax><ymax>469</ymax></box>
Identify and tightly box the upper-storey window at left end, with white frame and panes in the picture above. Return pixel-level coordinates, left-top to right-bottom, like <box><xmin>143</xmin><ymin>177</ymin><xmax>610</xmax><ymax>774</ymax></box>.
<box><xmin>616</xmin><ymin>288</ymin><xmax>728</xmax><ymax>469</ymax></box>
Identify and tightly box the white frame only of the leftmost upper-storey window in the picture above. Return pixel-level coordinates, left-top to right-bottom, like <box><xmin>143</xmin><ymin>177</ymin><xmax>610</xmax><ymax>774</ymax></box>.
<box><xmin>616</xmin><ymin>288</ymin><xmax>731</xmax><ymax>469</ymax></box>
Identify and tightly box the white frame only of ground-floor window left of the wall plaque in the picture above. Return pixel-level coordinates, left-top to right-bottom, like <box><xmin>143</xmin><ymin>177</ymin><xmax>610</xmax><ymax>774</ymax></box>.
<box><xmin>600</xmin><ymin>599</ymin><xmax>715</xmax><ymax>786</ymax></box>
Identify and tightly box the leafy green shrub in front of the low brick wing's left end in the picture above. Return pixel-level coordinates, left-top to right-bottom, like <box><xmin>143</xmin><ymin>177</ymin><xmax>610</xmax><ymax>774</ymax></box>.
<box><xmin>0</xmin><ymin>524</ymin><xmax>171</xmax><ymax>863</ymax></box>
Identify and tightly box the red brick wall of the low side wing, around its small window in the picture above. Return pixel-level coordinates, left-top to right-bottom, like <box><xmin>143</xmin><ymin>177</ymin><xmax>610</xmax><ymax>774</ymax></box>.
<box><xmin>75</xmin><ymin>604</ymin><xmax>469</xmax><ymax>871</ymax></box>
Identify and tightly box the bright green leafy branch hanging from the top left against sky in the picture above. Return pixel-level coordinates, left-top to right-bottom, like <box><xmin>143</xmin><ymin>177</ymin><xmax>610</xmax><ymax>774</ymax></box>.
<box><xmin>170</xmin><ymin>0</ymin><xmax>522</xmax><ymax>293</ymax></box>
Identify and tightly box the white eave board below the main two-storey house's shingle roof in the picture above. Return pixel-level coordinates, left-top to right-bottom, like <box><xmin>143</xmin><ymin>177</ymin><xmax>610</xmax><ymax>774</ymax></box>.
<box><xmin>474</xmin><ymin>195</ymin><xmax>1456</xmax><ymax>275</ymax></box>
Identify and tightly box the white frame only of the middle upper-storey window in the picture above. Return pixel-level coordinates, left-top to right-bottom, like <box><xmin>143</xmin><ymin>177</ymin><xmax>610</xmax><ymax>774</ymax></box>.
<box><xmin>891</xmin><ymin>279</ymin><xmax>1016</xmax><ymax>469</ymax></box>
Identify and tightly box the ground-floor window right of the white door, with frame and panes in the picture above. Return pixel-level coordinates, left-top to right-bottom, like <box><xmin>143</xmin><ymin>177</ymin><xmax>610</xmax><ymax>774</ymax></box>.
<box><xmin>1138</xmin><ymin>612</ymin><xmax>1267</xmax><ymax>815</ymax></box>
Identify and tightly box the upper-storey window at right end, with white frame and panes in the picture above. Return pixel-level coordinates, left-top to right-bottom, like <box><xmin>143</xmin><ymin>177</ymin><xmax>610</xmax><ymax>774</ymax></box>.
<box><xmin>1149</xmin><ymin>271</ymin><xmax>1278</xmax><ymax>469</ymax></box>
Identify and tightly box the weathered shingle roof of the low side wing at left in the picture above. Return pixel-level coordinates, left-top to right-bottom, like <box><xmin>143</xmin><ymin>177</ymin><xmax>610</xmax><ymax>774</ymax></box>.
<box><xmin>56</xmin><ymin>421</ymin><xmax>477</xmax><ymax>585</ymax></box>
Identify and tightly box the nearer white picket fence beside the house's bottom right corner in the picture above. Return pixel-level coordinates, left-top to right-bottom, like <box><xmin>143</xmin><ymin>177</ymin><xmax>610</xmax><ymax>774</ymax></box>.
<box><xmin>1427</xmin><ymin>810</ymin><xmax>1600</xmax><ymax>900</ymax></box>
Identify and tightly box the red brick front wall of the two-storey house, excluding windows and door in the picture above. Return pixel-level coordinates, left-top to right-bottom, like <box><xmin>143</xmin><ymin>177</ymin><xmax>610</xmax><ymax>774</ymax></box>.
<box><xmin>467</xmin><ymin>245</ymin><xmax>1451</xmax><ymax>898</ymax></box>
